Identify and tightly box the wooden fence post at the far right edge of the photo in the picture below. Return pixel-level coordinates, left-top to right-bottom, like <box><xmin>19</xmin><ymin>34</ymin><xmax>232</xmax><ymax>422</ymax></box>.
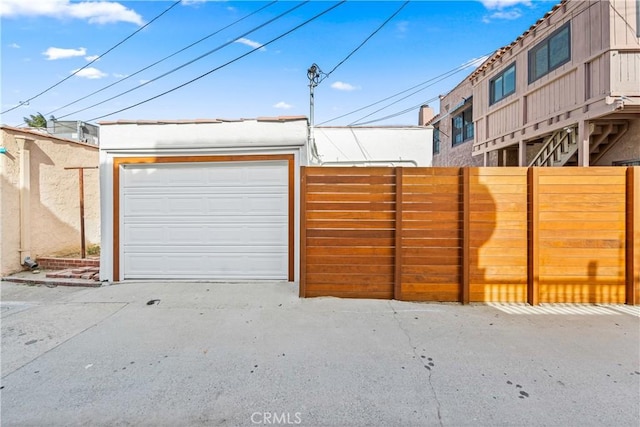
<box><xmin>625</xmin><ymin>167</ymin><xmax>640</xmax><ymax>305</ymax></box>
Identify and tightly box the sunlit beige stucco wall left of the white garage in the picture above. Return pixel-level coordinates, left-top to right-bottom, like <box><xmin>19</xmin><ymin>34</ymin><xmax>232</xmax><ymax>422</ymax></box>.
<box><xmin>0</xmin><ymin>127</ymin><xmax>100</xmax><ymax>275</ymax></box>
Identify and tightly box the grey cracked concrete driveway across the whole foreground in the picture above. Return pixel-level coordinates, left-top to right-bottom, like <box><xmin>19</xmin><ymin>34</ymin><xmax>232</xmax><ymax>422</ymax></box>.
<box><xmin>0</xmin><ymin>282</ymin><xmax>640</xmax><ymax>426</ymax></box>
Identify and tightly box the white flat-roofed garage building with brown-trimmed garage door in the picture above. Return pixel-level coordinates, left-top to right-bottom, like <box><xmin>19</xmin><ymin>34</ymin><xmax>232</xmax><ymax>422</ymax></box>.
<box><xmin>100</xmin><ymin>117</ymin><xmax>307</xmax><ymax>281</ymax></box>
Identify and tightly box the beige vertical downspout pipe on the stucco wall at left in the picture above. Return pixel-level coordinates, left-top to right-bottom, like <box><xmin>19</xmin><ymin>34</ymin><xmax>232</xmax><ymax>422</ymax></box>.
<box><xmin>16</xmin><ymin>136</ymin><xmax>33</xmax><ymax>264</ymax></box>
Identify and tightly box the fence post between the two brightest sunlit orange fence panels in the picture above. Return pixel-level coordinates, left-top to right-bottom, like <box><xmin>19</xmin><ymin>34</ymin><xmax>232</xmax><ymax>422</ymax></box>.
<box><xmin>527</xmin><ymin>167</ymin><xmax>540</xmax><ymax>305</ymax></box>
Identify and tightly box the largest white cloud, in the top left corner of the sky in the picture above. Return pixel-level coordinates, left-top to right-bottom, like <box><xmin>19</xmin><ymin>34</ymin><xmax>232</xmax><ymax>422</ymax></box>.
<box><xmin>0</xmin><ymin>0</ymin><xmax>144</xmax><ymax>25</ymax></box>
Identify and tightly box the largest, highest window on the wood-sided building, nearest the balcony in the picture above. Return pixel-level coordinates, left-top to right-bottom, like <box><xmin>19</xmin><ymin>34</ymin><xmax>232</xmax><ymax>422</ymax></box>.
<box><xmin>529</xmin><ymin>22</ymin><xmax>571</xmax><ymax>83</ymax></box>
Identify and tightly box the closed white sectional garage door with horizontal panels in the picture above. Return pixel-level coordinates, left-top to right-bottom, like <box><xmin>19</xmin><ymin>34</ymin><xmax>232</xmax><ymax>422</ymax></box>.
<box><xmin>121</xmin><ymin>161</ymin><xmax>289</xmax><ymax>280</ymax></box>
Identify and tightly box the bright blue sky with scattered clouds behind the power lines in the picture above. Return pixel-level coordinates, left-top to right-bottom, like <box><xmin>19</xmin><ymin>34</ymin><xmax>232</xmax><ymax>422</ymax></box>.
<box><xmin>0</xmin><ymin>0</ymin><xmax>556</xmax><ymax>126</ymax></box>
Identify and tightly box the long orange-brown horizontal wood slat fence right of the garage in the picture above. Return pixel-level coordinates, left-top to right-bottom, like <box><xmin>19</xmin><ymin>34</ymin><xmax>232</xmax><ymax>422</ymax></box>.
<box><xmin>300</xmin><ymin>167</ymin><xmax>640</xmax><ymax>304</ymax></box>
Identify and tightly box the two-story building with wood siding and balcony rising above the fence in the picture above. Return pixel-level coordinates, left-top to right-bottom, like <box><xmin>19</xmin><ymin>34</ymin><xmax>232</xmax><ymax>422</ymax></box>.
<box><xmin>431</xmin><ymin>0</ymin><xmax>640</xmax><ymax>166</ymax></box>
